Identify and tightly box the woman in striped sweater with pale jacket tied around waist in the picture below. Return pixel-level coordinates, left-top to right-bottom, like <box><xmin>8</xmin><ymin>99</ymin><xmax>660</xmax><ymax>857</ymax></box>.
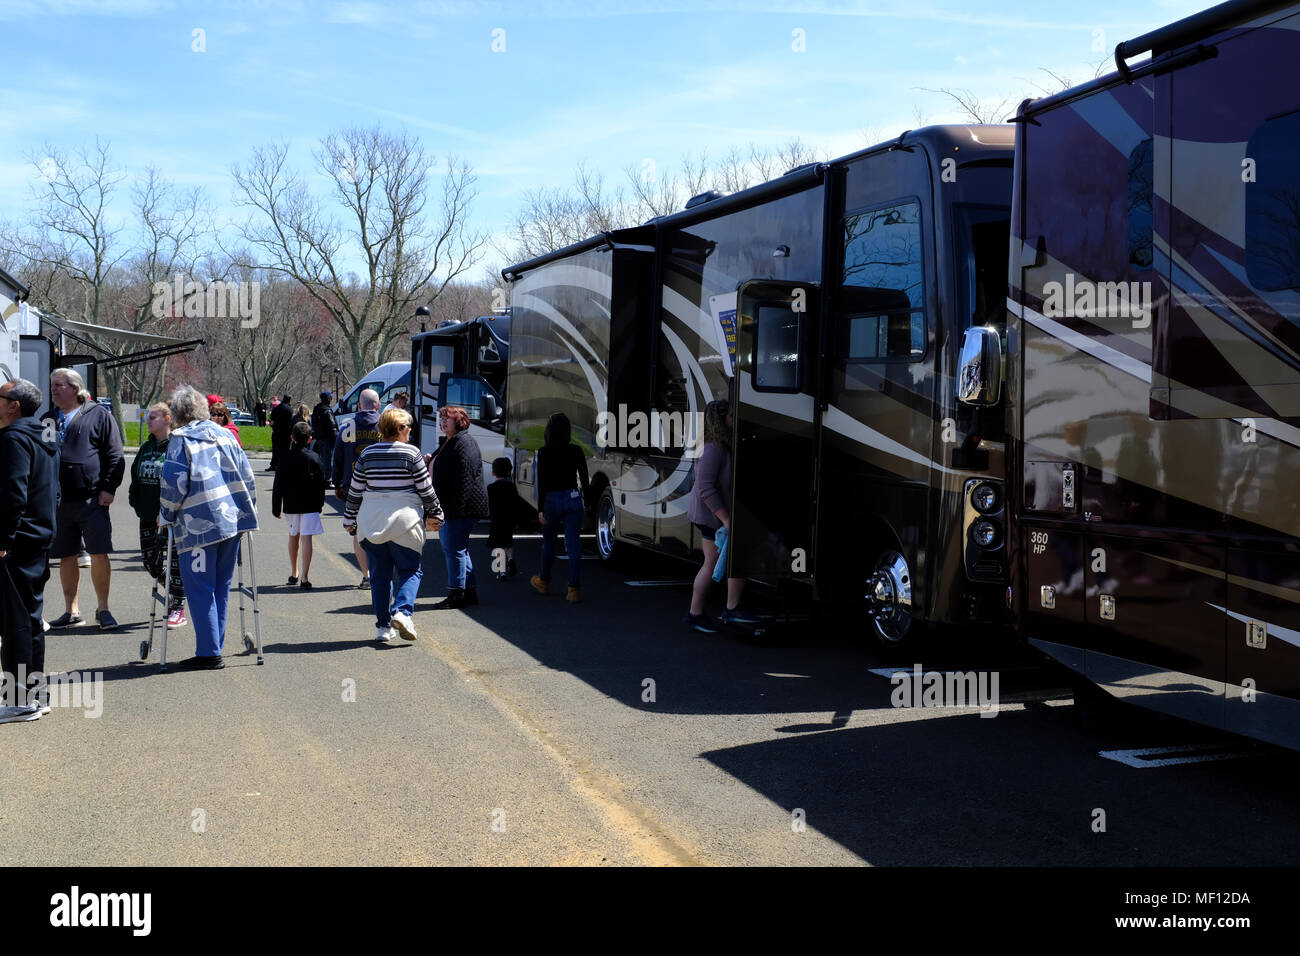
<box><xmin>343</xmin><ymin>408</ymin><xmax>443</xmax><ymax>644</ymax></box>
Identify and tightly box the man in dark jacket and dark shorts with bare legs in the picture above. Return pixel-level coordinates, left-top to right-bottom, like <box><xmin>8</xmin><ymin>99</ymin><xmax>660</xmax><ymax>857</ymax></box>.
<box><xmin>49</xmin><ymin>368</ymin><xmax>126</xmax><ymax>630</ymax></box>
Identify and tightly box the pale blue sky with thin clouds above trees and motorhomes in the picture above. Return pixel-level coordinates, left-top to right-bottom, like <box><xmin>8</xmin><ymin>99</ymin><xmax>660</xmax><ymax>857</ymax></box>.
<box><xmin>0</xmin><ymin>0</ymin><xmax>1209</xmax><ymax>278</ymax></box>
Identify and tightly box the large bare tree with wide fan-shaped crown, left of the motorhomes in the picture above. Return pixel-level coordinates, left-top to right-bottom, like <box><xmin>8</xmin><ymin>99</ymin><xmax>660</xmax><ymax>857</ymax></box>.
<box><xmin>233</xmin><ymin>127</ymin><xmax>486</xmax><ymax>376</ymax></box>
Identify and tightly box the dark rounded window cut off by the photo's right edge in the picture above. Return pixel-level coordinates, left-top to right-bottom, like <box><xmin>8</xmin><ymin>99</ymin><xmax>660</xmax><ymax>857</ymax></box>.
<box><xmin>1243</xmin><ymin>112</ymin><xmax>1300</xmax><ymax>293</ymax></box>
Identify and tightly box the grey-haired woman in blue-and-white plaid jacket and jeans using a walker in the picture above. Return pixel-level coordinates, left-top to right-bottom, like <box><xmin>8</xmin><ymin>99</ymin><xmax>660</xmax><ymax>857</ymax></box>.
<box><xmin>159</xmin><ymin>385</ymin><xmax>257</xmax><ymax>670</ymax></box>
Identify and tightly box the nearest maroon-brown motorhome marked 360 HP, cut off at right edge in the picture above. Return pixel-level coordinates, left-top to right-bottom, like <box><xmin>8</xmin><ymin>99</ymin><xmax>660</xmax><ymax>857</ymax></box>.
<box><xmin>962</xmin><ymin>1</ymin><xmax>1300</xmax><ymax>748</ymax></box>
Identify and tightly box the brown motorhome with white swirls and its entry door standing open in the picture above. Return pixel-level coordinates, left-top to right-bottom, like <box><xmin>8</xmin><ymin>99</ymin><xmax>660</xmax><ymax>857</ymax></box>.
<box><xmin>503</xmin><ymin>126</ymin><xmax>1013</xmax><ymax>646</ymax></box>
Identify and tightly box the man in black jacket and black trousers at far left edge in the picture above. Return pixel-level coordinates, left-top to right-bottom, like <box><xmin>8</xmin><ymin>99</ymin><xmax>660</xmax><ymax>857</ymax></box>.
<box><xmin>0</xmin><ymin>378</ymin><xmax>59</xmax><ymax>723</ymax></box>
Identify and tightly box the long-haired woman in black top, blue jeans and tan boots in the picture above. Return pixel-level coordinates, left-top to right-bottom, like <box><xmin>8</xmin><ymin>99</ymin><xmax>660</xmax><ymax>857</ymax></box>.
<box><xmin>532</xmin><ymin>412</ymin><xmax>592</xmax><ymax>604</ymax></box>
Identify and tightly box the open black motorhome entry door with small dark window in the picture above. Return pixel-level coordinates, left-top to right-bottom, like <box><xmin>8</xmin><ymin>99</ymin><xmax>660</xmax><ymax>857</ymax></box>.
<box><xmin>727</xmin><ymin>280</ymin><xmax>820</xmax><ymax>585</ymax></box>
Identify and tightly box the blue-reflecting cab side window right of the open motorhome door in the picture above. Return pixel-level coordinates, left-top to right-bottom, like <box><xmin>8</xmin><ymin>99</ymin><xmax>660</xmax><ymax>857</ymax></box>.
<box><xmin>836</xmin><ymin>202</ymin><xmax>926</xmax><ymax>362</ymax></box>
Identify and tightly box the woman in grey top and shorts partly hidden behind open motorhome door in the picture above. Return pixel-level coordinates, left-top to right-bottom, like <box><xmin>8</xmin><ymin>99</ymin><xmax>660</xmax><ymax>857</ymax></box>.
<box><xmin>684</xmin><ymin>399</ymin><xmax>750</xmax><ymax>633</ymax></box>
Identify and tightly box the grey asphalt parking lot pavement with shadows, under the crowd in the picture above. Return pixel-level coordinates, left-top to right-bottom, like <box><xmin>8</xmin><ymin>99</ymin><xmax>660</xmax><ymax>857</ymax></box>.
<box><xmin>0</xmin><ymin>458</ymin><xmax>1300</xmax><ymax>866</ymax></box>
